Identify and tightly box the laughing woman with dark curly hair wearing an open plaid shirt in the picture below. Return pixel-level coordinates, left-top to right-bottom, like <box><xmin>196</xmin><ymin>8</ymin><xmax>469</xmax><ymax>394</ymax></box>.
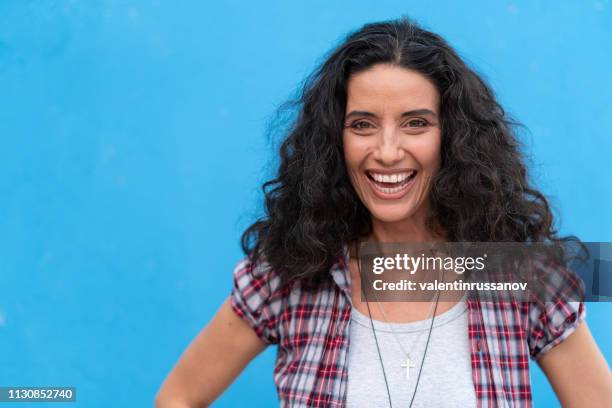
<box><xmin>156</xmin><ymin>18</ymin><xmax>612</xmax><ymax>407</ymax></box>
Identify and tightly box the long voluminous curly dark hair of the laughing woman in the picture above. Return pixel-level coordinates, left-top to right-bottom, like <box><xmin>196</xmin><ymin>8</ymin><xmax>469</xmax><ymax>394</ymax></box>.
<box><xmin>241</xmin><ymin>17</ymin><xmax>572</xmax><ymax>285</ymax></box>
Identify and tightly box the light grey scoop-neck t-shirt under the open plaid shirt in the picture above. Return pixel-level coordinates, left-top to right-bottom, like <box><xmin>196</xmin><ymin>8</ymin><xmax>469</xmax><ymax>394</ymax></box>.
<box><xmin>347</xmin><ymin>296</ymin><xmax>476</xmax><ymax>408</ymax></box>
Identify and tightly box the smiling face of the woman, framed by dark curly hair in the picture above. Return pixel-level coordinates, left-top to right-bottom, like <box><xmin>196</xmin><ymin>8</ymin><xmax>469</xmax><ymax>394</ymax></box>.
<box><xmin>343</xmin><ymin>64</ymin><xmax>441</xmax><ymax>222</ymax></box>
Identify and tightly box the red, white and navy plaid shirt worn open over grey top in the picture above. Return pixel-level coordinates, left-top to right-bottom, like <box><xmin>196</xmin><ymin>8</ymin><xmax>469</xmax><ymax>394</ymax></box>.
<box><xmin>231</xmin><ymin>248</ymin><xmax>586</xmax><ymax>407</ymax></box>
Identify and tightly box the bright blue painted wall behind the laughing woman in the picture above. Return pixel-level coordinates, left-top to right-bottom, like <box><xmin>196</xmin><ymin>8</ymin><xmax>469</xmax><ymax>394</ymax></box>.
<box><xmin>0</xmin><ymin>0</ymin><xmax>612</xmax><ymax>407</ymax></box>
